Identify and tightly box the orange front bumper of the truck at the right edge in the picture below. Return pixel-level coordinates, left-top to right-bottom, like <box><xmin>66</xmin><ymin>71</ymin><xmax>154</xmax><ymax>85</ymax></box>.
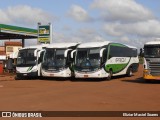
<box><xmin>143</xmin><ymin>70</ymin><xmax>160</xmax><ymax>80</ymax></box>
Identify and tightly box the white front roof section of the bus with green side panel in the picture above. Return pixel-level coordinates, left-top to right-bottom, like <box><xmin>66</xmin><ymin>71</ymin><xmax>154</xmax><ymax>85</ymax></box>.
<box><xmin>78</xmin><ymin>41</ymin><xmax>110</xmax><ymax>48</ymax></box>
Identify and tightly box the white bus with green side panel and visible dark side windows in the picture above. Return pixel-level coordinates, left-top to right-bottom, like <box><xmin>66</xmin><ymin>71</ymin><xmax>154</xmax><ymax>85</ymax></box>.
<box><xmin>74</xmin><ymin>41</ymin><xmax>139</xmax><ymax>79</ymax></box>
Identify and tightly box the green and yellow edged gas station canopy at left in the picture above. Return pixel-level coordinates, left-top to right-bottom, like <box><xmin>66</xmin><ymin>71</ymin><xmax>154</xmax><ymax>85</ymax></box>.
<box><xmin>0</xmin><ymin>24</ymin><xmax>38</xmax><ymax>47</ymax></box>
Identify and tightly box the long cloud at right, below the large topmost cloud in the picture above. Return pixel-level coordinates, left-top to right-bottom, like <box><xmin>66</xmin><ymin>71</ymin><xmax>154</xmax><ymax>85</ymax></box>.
<box><xmin>104</xmin><ymin>20</ymin><xmax>160</xmax><ymax>37</ymax></box>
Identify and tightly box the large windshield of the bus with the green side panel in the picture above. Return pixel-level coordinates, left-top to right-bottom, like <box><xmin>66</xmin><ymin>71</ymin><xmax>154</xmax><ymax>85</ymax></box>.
<box><xmin>75</xmin><ymin>48</ymin><xmax>100</xmax><ymax>70</ymax></box>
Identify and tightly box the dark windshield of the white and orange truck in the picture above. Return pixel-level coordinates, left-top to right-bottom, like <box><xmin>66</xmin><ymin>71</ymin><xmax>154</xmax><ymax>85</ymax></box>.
<box><xmin>144</xmin><ymin>45</ymin><xmax>160</xmax><ymax>58</ymax></box>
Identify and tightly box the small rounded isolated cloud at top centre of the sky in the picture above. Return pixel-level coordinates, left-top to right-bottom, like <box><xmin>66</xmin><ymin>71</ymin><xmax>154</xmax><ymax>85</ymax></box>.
<box><xmin>68</xmin><ymin>5</ymin><xmax>92</xmax><ymax>22</ymax></box>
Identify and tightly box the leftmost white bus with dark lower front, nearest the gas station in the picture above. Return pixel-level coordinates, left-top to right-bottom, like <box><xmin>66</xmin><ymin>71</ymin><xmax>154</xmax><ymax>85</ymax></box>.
<box><xmin>16</xmin><ymin>44</ymin><xmax>48</xmax><ymax>79</ymax></box>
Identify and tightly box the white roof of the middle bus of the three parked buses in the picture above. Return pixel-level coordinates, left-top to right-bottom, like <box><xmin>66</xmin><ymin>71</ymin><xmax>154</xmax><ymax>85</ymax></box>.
<box><xmin>47</xmin><ymin>43</ymin><xmax>79</xmax><ymax>48</ymax></box>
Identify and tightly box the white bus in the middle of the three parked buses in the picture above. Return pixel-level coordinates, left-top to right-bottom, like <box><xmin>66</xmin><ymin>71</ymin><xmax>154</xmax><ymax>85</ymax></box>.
<box><xmin>41</xmin><ymin>43</ymin><xmax>78</xmax><ymax>77</ymax></box>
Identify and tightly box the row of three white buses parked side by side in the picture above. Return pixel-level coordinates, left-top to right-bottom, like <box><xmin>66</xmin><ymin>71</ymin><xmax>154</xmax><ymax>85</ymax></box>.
<box><xmin>16</xmin><ymin>41</ymin><xmax>139</xmax><ymax>79</ymax></box>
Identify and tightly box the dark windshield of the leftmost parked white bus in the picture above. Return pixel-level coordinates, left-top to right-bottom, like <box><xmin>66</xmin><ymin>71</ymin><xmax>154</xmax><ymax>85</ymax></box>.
<box><xmin>17</xmin><ymin>49</ymin><xmax>37</xmax><ymax>67</ymax></box>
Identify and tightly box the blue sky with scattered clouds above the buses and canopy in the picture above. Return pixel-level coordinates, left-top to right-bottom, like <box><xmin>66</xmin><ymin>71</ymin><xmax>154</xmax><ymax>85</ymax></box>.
<box><xmin>0</xmin><ymin>0</ymin><xmax>160</xmax><ymax>48</ymax></box>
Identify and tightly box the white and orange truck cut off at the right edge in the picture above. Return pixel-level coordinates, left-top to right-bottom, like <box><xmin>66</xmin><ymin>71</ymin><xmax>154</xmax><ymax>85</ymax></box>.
<box><xmin>143</xmin><ymin>40</ymin><xmax>160</xmax><ymax>81</ymax></box>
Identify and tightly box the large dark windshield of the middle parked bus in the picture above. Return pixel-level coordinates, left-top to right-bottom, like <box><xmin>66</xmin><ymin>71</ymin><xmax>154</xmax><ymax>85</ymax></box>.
<box><xmin>42</xmin><ymin>48</ymin><xmax>66</xmax><ymax>70</ymax></box>
